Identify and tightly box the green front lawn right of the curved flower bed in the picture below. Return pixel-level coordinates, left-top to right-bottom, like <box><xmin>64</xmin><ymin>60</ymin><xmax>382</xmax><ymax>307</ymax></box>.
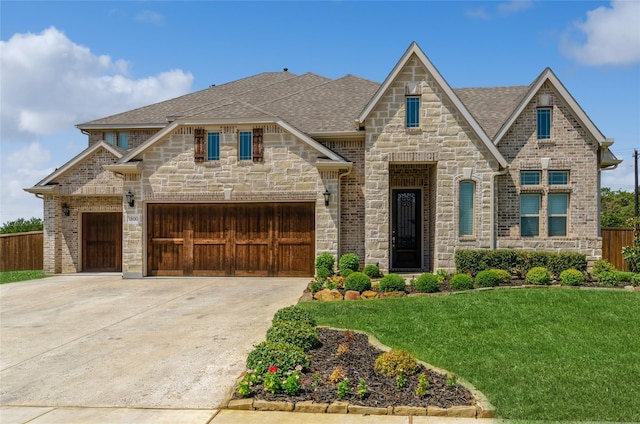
<box><xmin>300</xmin><ymin>288</ymin><xmax>640</xmax><ymax>421</ymax></box>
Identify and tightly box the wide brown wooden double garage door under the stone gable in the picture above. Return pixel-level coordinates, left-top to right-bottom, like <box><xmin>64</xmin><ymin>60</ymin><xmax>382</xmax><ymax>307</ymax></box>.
<box><xmin>147</xmin><ymin>203</ymin><xmax>315</xmax><ymax>277</ymax></box>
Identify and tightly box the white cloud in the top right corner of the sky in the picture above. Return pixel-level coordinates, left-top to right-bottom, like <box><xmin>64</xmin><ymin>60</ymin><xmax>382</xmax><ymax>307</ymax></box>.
<box><xmin>560</xmin><ymin>0</ymin><xmax>640</xmax><ymax>66</ymax></box>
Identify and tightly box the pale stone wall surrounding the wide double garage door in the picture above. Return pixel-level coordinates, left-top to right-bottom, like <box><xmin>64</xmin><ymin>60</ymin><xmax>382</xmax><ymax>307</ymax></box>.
<box><xmin>123</xmin><ymin>125</ymin><xmax>338</xmax><ymax>277</ymax></box>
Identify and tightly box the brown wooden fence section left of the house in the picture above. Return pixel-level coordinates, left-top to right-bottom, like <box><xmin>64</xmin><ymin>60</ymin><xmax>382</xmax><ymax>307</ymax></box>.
<box><xmin>0</xmin><ymin>231</ymin><xmax>43</xmax><ymax>271</ymax></box>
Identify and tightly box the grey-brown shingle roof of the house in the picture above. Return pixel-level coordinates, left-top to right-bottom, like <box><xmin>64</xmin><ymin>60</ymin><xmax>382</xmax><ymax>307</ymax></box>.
<box><xmin>78</xmin><ymin>72</ymin><xmax>528</xmax><ymax>138</ymax></box>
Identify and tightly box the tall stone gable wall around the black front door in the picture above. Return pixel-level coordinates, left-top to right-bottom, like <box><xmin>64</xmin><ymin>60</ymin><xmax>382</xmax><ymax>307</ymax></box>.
<box><xmin>365</xmin><ymin>56</ymin><xmax>498</xmax><ymax>271</ymax></box>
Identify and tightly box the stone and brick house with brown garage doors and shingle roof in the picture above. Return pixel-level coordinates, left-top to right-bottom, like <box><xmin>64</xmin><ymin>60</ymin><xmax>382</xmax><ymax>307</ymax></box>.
<box><xmin>26</xmin><ymin>43</ymin><xmax>620</xmax><ymax>278</ymax></box>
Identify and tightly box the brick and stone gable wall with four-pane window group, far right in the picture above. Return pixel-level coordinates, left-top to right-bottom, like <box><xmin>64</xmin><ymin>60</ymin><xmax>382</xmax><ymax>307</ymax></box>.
<box><xmin>497</xmin><ymin>82</ymin><xmax>602</xmax><ymax>261</ymax></box>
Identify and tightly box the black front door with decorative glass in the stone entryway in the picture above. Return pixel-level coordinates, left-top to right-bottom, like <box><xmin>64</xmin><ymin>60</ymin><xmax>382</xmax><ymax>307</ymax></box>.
<box><xmin>391</xmin><ymin>189</ymin><xmax>422</xmax><ymax>269</ymax></box>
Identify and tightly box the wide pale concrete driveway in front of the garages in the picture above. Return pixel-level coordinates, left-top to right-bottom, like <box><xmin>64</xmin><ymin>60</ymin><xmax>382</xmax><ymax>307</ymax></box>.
<box><xmin>0</xmin><ymin>274</ymin><xmax>309</xmax><ymax>409</ymax></box>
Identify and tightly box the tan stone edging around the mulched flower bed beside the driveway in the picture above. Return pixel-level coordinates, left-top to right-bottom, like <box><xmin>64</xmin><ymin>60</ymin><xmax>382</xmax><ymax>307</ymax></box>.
<box><xmin>223</xmin><ymin>327</ymin><xmax>496</xmax><ymax>418</ymax></box>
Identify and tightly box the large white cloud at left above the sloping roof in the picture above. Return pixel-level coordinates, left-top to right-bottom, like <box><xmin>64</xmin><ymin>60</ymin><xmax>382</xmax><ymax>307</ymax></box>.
<box><xmin>0</xmin><ymin>27</ymin><xmax>193</xmax><ymax>139</ymax></box>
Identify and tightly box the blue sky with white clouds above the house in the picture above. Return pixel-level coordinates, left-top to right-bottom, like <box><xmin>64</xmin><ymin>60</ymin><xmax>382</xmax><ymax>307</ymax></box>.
<box><xmin>0</xmin><ymin>0</ymin><xmax>640</xmax><ymax>223</ymax></box>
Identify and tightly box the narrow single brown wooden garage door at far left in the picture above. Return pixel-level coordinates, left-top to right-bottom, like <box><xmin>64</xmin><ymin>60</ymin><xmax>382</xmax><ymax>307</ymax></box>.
<box><xmin>82</xmin><ymin>212</ymin><xmax>122</xmax><ymax>272</ymax></box>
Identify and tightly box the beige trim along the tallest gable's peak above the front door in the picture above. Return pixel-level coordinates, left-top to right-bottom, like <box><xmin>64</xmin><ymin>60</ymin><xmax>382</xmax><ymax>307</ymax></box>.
<box><xmin>356</xmin><ymin>41</ymin><xmax>507</xmax><ymax>167</ymax></box>
